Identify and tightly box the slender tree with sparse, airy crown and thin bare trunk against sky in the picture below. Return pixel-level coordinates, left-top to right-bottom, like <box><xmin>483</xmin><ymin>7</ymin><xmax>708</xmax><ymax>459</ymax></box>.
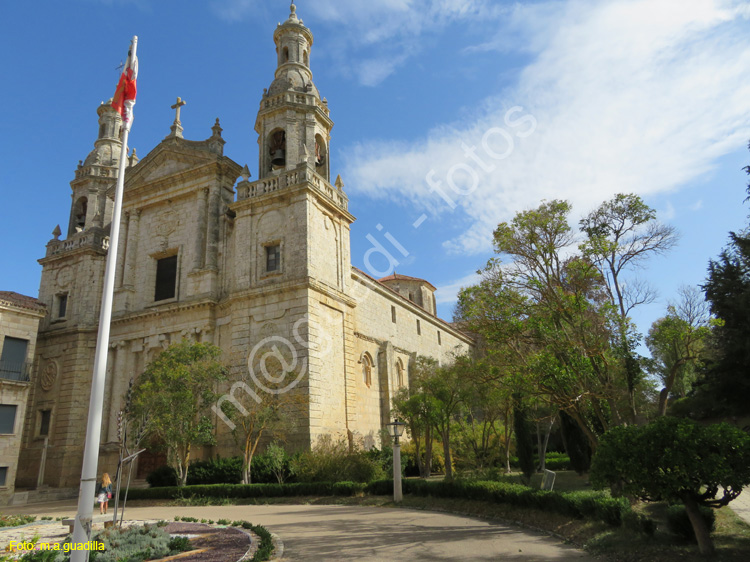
<box><xmin>580</xmin><ymin>193</ymin><xmax>678</xmax><ymax>421</ymax></box>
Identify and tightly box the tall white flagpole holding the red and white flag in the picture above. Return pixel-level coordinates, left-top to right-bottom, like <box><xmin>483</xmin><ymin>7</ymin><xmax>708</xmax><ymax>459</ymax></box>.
<box><xmin>70</xmin><ymin>36</ymin><xmax>138</xmax><ymax>562</ymax></box>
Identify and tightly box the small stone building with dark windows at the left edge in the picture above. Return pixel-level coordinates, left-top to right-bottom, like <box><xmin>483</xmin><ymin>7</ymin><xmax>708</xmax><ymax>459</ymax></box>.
<box><xmin>0</xmin><ymin>291</ymin><xmax>47</xmax><ymax>505</ymax></box>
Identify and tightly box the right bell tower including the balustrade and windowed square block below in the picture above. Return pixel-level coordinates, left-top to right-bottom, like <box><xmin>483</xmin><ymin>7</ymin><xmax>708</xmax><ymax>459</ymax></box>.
<box><xmin>232</xmin><ymin>4</ymin><xmax>354</xmax><ymax>293</ymax></box>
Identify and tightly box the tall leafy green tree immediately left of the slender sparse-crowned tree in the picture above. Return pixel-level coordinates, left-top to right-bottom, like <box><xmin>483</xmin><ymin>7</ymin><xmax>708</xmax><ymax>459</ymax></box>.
<box><xmin>488</xmin><ymin>201</ymin><xmax>620</xmax><ymax>448</ymax></box>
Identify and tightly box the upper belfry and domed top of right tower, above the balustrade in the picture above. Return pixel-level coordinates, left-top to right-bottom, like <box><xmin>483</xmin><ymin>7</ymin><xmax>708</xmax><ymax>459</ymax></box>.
<box><xmin>255</xmin><ymin>4</ymin><xmax>333</xmax><ymax>181</ymax></box>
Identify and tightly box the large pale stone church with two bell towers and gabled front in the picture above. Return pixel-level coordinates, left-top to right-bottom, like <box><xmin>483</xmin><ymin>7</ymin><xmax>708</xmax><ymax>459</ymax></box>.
<box><xmin>17</xmin><ymin>6</ymin><xmax>473</xmax><ymax>487</ymax></box>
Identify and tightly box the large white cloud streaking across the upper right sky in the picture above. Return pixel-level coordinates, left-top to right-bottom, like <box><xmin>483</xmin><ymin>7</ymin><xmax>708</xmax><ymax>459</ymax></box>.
<box><xmin>345</xmin><ymin>0</ymin><xmax>750</xmax><ymax>252</ymax></box>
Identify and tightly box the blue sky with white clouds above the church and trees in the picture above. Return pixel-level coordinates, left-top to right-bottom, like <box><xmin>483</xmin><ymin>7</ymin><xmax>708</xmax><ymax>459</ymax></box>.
<box><xmin>0</xmin><ymin>0</ymin><xmax>750</xmax><ymax>346</ymax></box>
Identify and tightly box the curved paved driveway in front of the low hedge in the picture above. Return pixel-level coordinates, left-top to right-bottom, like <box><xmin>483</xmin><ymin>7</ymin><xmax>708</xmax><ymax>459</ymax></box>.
<box><xmin>0</xmin><ymin>502</ymin><xmax>594</xmax><ymax>562</ymax></box>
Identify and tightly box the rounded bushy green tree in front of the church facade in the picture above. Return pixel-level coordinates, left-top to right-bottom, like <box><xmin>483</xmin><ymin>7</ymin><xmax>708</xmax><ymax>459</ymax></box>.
<box><xmin>129</xmin><ymin>341</ymin><xmax>227</xmax><ymax>486</ymax></box>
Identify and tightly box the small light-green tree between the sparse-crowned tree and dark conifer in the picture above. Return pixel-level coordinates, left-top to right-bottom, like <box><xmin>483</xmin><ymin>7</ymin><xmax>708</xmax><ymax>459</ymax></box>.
<box><xmin>646</xmin><ymin>286</ymin><xmax>710</xmax><ymax>416</ymax></box>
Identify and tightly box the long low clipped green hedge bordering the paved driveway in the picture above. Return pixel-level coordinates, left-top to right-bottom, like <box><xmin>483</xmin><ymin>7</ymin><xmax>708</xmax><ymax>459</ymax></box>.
<box><xmin>128</xmin><ymin>479</ymin><xmax>630</xmax><ymax>526</ymax></box>
